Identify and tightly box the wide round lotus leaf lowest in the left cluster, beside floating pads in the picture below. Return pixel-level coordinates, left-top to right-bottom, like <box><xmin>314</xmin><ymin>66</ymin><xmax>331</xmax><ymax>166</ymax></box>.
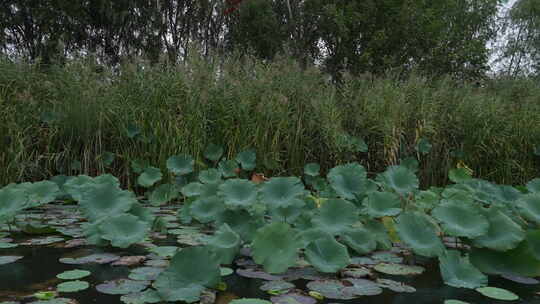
<box><xmin>99</xmin><ymin>214</ymin><xmax>150</xmax><ymax>248</ymax></box>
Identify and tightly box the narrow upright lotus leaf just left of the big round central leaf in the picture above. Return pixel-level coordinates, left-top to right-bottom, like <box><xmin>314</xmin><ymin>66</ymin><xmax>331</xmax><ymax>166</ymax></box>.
<box><xmin>207</xmin><ymin>224</ymin><xmax>241</xmax><ymax>265</ymax></box>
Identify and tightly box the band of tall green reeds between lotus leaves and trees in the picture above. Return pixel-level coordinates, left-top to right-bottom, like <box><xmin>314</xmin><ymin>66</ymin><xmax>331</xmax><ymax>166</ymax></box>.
<box><xmin>0</xmin><ymin>58</ymin><xmax>540</xmax><ymax>186</ymax></box>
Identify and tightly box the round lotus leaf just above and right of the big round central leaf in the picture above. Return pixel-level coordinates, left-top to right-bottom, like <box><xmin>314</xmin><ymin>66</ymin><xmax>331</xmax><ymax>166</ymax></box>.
<box><xmin>312</xmin><ymin>199</ymin><xmax>358</xmax><ymax>235</ymax></box>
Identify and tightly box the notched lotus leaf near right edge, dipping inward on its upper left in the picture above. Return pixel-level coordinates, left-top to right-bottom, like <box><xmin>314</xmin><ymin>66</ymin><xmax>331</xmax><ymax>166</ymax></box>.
<box><xmin>474</xmin><ymin>207</ymin><xmax>525</xmax><ymax>251</ymax></box>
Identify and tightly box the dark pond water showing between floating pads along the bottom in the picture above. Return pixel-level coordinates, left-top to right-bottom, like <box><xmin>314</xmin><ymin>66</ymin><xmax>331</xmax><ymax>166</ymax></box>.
<box><xmin>0</xmin><ymin>246</ymin><xmax>540</xmax><ymax>304</ymax></box>
